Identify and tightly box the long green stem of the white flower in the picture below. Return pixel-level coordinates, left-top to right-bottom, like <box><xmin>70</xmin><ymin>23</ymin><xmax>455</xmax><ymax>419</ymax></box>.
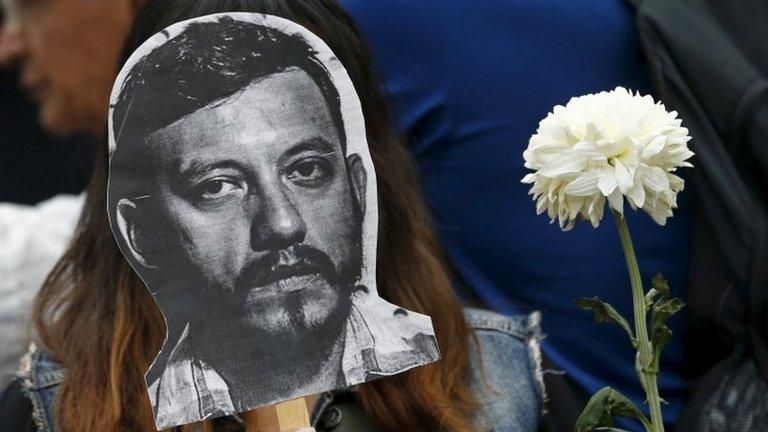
<box><xmin>613</xmin><ymin>210</ymin><xmax>664</xmax><ymax>432</ymax></box>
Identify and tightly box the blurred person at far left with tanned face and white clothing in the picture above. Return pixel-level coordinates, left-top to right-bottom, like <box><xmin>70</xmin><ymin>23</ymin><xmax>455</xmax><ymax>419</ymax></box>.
<box><xmin>0</xmin><ymin>0</ymin><xmax>148</xmax><ymax>388</ymax></box>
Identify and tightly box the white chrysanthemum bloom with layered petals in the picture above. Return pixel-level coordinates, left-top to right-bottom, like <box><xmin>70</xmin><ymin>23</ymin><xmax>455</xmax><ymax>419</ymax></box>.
<box><xmin>522</xmin><ymin>87</ymin><xmax>693</xmax><ymax>231</ymax></box>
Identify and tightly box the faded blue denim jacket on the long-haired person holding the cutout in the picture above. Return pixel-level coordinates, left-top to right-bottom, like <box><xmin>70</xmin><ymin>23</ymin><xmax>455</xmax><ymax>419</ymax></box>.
<box><xmin>19</xmin><ymin>309</ymin><xmax>545</xmax><ymax>432</ymax></box>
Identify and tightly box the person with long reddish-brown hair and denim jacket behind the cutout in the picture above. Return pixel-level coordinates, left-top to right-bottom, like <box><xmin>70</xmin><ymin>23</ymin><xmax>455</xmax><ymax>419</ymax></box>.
<box><xmin>0</xmin><ymin>0</ymin><xmax>542</xmax><ymax>432</ymax></box>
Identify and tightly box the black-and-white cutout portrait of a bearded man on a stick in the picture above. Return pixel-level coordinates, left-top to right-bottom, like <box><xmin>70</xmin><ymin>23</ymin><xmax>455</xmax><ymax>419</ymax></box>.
<box><xmin>108</xmin><ymin>13</ymin><xmax>439</xmax><ymax>429</ymax></box>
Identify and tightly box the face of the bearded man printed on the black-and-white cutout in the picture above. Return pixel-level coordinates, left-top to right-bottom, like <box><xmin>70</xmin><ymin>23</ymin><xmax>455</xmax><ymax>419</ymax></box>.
<box><xmin>149</xmin><ymin>68</ymin><xmax>364</xmax><ymax>340</ymax></box>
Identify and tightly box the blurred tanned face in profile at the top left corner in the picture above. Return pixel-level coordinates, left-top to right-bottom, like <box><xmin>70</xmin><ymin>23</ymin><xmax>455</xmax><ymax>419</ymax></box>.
<box><xmin>0</xmin><ymin>0</ymin><xmax>138</xmax><ymax>135</ymax></box>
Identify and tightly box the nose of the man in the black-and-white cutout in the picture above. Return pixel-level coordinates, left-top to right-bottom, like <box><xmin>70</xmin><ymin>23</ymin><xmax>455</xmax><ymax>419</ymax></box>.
<box><xmin>251</xmin><ymin>181</ymin><xmax>307</xmax><ymax>251</ymax></box>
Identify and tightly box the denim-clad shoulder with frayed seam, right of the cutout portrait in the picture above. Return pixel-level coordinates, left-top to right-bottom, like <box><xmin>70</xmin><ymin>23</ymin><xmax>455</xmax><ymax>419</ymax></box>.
<box><xmin>465</xmin><ymin>309</ymin><xmax>545</xmax><ymax>431</ymax></box>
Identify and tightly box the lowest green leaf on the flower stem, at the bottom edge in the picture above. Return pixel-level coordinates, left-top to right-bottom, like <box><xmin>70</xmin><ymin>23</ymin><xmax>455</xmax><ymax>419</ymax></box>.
<box><xmin>575</xmin><ymin>387</ymin><xmax>653</xmax><ymax>432</ymax></box>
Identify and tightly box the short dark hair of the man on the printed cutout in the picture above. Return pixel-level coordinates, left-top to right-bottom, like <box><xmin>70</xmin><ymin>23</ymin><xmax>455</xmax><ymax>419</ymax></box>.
<box><xmin>112</xmin><ymin>17</ymin><xmax>346</xmax><ymax>189</ymax></box>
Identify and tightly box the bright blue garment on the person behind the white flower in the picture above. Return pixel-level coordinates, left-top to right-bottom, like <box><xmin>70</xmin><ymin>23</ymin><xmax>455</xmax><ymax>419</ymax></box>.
<box><xmin>341</xmin><ymin>0</ymin><xmax>692</xmax><ymax>430</ymax></box>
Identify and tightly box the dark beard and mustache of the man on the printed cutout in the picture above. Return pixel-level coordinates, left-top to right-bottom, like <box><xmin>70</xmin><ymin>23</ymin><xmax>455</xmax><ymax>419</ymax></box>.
<box><xmin>162</xmin><ymin>243</ymin><xmax>362</xmax><ymax>380</ymax></box>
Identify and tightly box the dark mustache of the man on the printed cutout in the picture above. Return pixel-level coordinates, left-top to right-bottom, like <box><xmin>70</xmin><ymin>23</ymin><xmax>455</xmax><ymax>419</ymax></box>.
<box><xmin>235</xmin><ymin>244</ymin><xmax>340</xmax><ymax>292</ymax></box>
